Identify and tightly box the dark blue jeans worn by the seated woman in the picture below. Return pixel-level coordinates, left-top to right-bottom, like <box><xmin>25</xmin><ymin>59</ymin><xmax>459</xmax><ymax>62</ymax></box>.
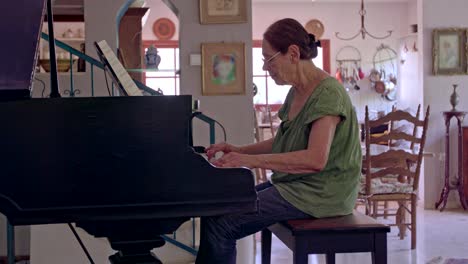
<box><xmin>195</xmin><ymin>182</ymin><xmax>310</xmax><ymax>264</ymax></box>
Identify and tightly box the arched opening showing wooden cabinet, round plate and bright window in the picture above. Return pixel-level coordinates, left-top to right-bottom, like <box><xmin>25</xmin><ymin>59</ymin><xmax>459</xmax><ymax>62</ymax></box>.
<box><xmin>117</xmin><ymin>0</ymin><xmax>180</xmax><ymax>95</ymax></box>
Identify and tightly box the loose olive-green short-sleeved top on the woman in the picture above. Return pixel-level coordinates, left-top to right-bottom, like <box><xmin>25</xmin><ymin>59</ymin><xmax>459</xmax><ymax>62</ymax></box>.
<box><xmin>271</xmin><ymin>77</ymin><xmax>362</xmax><ymax>218</ymax></box>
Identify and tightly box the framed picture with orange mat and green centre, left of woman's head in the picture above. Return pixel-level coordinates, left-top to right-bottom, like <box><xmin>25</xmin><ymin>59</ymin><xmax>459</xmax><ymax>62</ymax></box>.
<box><xmin>201</xmin><ymin>42</ymin><xmax>245</xmax><ymax>95</ymax></box>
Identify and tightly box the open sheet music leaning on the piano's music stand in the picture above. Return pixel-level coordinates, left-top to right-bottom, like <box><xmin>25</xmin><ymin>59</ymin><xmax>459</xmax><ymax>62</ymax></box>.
<box><xmin>97</xmin><ymin>40</ymin><xmax>143</xmax><ymax>96</ymax></box>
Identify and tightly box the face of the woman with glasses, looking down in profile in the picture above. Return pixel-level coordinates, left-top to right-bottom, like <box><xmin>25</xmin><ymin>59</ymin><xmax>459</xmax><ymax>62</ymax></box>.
<box><xmin>262</xmin><ymin>40</ymin><xmax>288</xmax><ymax>85</ymax></box>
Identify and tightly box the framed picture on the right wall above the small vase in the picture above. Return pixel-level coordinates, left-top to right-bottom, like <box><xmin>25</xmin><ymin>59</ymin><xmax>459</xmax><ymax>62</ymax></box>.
<box><xmin>432</xmin><ymin>28</ymin><xmax>467</xmax><ymax>75</ymax></box>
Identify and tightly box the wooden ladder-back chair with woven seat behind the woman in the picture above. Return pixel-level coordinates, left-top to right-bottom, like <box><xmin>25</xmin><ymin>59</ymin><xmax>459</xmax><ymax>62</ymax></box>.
<box><xmin>360</xmin><ymin>106</ymin><xmax>429</xmax><ymax>249</ymax></box>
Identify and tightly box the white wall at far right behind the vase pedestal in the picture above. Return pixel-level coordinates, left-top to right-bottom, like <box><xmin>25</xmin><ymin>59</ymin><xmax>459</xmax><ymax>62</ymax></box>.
<box><xmin>419</xmin><ymin>0</ymin><xmax>468</xmax><ymax>208</ymax></box>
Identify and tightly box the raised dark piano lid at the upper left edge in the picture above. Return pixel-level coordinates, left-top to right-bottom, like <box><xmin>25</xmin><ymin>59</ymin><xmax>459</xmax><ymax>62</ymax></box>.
<box><xmin>0</xmin><ymin>0</ymin><xmax>45</xmax><ymax>98</ymax></box>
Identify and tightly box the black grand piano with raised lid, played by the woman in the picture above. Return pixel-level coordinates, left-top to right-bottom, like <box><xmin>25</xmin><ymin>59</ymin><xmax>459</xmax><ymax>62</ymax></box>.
<box><xmin>0</xmin><ymin>0</ymin><xmax>257</xmax><ymax>263</ymax></box>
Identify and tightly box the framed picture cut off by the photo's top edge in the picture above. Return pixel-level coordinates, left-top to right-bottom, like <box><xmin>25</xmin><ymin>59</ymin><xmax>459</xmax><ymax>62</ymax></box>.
<box><xmin>199</xmin><ymin>0</ymin><xmax>247</xmax><ymax>24</ymax></box>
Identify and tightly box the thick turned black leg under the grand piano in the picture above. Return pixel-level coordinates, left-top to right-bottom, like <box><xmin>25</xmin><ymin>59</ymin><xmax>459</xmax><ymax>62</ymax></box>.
<box><xmin>109</xmin><ymin>237</ymin><xmax>165</xmax><ymax>264</ymax></box>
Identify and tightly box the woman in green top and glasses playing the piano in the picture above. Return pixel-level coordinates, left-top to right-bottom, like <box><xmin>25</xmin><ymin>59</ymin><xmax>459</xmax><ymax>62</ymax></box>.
<box><xmin>196</xmin><ymin>18</ymin><xmax>361</xmax><ymax>264</ymax></box>
